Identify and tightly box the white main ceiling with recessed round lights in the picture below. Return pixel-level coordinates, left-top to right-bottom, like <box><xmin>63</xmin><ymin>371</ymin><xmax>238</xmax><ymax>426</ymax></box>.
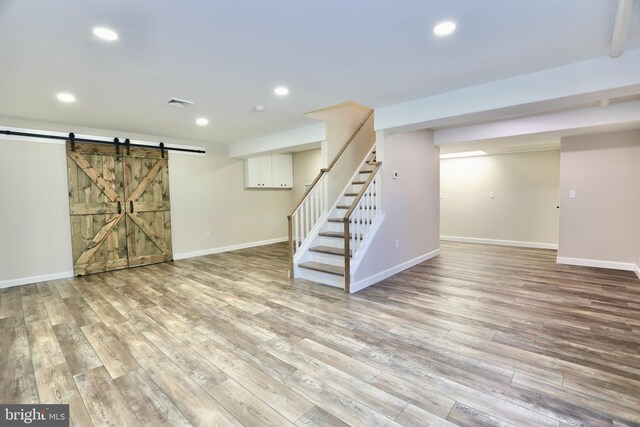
<box><xmin>0</xmin><ymin>0</ymin><xmax>640</xmax><ymax>143</ymax></box>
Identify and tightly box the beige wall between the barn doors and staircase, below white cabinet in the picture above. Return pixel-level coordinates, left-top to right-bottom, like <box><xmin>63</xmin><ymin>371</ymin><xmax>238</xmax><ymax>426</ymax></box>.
<box><xmin>169</xmin><ymin>144</ymin><xmax>291</xmax><ymax>258</ymax></box>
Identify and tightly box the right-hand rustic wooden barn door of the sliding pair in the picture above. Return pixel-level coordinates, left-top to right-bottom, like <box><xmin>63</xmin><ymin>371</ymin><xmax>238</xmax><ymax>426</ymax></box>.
<box><xmin>123</xmin><ymin>148</ymin><xmax>173</xmax><ymax>267</ymax></box>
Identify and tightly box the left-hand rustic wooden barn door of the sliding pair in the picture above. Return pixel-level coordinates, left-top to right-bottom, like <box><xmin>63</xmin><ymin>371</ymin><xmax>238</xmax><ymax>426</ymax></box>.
<box><xmin>67</xmin><ymin>143</ymin><xmax>129</xmax><ymax>275</ymax></box>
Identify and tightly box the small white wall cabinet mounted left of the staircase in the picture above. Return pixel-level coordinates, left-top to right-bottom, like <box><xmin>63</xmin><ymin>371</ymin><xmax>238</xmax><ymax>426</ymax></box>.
<box><xmin>244</xmin><ymin>154</ymin><xmax>293</xmax><ymax>188</ymax></box>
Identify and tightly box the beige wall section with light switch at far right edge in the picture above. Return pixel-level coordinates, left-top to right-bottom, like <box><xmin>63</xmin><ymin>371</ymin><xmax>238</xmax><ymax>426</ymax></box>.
<box><xmin>558</xmin><ymin>130</ymin><xmax>640</xmax><ymax>269</ymax></box>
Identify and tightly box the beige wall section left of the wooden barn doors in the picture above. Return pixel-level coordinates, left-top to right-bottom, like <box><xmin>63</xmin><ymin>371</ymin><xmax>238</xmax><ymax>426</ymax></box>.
<box><xmin>0</xmin><ymin>140</ymin><xmax>73</xmax><ymax>284</ymax></box>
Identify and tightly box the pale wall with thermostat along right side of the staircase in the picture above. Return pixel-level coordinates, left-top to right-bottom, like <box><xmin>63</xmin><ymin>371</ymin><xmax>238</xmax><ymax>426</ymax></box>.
<box><xmin>352</xmin><ymin>130</ymin><xmax>440</xmax><ymax>290</ymax></box>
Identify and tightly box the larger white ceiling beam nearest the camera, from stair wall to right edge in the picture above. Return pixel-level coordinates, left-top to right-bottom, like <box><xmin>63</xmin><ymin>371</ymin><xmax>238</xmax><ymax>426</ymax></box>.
<box><xmin>375</xmin><ymin>49</ymin><xmax>640</xmax><ymax>131</ymax></box>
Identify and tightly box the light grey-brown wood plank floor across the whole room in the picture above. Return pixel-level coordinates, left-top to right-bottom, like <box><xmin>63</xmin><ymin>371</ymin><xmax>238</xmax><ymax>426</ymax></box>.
<box><xmin>0</xmin><ymin>243</ymin><xmax>640</xmax><ymax>427</ymax></box>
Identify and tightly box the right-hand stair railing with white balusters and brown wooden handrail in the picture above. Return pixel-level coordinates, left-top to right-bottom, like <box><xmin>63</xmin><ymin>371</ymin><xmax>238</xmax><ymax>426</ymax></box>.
<box><xmin>342</xmin><ymin>162</ymin><xmax>382</xmax><ymax>293</ymax></box>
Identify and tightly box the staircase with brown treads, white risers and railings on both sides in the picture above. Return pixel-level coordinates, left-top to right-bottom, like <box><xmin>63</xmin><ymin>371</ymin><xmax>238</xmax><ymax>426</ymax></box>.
<box><xmin>288</xmin><ymin>113</ymin><xmax>383</xmax><ymax>292</ymax></box>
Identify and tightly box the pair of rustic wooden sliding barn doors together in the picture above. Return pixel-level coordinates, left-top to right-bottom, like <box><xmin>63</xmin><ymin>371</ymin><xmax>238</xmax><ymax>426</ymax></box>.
<box><xmin>67</xmin><ymin>143</ymin><xmax>173</xmax><ymax>275</ymax></box>
